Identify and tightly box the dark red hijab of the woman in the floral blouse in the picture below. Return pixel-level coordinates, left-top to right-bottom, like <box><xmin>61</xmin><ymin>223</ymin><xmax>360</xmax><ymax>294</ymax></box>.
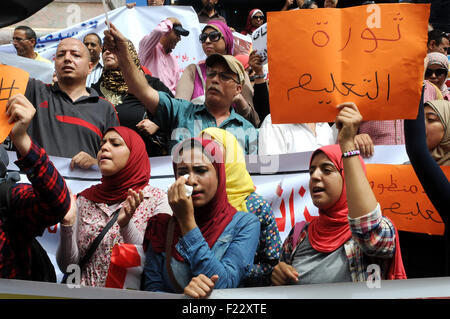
<box><xmin>80</xmin><ymin>126</ymin><xmax>150</xmax><ymax>205</ymax></box>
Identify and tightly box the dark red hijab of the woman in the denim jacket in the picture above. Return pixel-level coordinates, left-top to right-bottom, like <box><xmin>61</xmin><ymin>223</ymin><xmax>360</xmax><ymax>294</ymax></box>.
<box><xmin>144</xmin><ymin>138</ymin><xmax>236</xmax><ymax>261</ymax></box>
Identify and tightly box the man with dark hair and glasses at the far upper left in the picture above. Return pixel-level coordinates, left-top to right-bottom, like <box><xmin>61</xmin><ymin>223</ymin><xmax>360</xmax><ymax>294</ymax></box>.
<box><xmin>11</xmin><ymin>25</ymin><xmax>51</xmax><ymax>63</ymax></box>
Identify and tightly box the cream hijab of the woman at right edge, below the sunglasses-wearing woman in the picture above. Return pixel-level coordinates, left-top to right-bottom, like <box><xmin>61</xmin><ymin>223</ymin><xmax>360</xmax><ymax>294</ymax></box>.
<box><xmin>425</xmin><ymin>100</ymin><xmax>450</xmax><ymax>166</ymax></box>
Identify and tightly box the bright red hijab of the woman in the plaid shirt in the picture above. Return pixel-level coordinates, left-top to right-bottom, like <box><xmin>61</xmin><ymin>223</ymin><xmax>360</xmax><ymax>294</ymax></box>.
<box><xmin>308</xmin><ymin>144</ymin><xmax>406</xmax><ymax>279</ymax></box>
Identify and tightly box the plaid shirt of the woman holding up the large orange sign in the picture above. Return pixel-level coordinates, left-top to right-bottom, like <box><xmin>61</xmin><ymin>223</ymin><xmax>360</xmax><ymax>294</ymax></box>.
<box><xmin>280</xmin><ymin>204</ymin><xmax>395</xmax><ymax>282</ymax></box>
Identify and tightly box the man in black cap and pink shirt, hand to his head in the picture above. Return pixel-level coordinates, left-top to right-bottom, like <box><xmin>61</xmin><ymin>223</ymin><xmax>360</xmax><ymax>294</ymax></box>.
<box><xmin>139</xmin><ymin>18</ymin><xmax>189</xmax><ymax>95</ymax></box>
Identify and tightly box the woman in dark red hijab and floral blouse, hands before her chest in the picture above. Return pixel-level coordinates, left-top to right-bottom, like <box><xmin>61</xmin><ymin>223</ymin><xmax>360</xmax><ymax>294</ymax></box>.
<box><xmin>56</xmin><ymin>126</ymin><xmax>171</xmax><ymax>287</ymax></box>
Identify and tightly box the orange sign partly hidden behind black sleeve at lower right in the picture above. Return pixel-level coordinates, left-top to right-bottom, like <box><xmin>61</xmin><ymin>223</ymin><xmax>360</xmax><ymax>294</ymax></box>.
<box><xmin>367</xmin><ymin>164</ymin><xmax>450</xmax><ymax>235</ymax></box>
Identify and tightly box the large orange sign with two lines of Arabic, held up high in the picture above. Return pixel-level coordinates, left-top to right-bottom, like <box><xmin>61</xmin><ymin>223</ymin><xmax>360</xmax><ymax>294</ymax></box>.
<box><xmin>267</xmin><ymin>3</ymin><xmax>430</xmax><ymax>123</ymax></box>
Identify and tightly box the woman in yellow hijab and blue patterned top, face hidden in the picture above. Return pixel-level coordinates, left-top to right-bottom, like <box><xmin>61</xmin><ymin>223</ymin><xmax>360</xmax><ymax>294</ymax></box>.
<box><xmin>200</xmin><ymin>127</ymin><xmax>282</xmax><ymax>287</ymax></box>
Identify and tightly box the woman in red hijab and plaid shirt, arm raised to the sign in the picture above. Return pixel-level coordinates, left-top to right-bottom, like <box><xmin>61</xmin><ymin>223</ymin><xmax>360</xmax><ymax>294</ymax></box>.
<box><xmin>272</xmin><ymin>103</ymin><xmax>406</xmax><ymax>285</ymax></box>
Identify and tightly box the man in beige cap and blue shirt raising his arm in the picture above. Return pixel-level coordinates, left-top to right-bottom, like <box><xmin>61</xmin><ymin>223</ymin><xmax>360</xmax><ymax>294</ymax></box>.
<box><xmin>104</xmin><ymin>25</ymin><xmax>258</xmax><ymax>154</ymax></box>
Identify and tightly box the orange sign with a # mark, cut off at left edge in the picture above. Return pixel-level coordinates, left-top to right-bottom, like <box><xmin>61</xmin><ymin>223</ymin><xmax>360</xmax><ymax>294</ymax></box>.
<box><xmin>0</xmin><ymin>65</ymin><xmax>29</xmax><ymax>143</ymax></box>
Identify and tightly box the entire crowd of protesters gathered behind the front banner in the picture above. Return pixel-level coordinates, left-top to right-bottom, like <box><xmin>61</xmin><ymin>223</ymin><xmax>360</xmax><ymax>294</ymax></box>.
<box><xmin>0</xmin><ymin>0</ymin><xmax>450</xmax><ymax>298</ymax></box>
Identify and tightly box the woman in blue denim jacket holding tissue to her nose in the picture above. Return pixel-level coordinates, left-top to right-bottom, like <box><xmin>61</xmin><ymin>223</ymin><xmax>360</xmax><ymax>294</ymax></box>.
<box><xmin>143</xmin><ymin>138</ymin><xmax>260</xmax><ymax>297</ymax></box>
